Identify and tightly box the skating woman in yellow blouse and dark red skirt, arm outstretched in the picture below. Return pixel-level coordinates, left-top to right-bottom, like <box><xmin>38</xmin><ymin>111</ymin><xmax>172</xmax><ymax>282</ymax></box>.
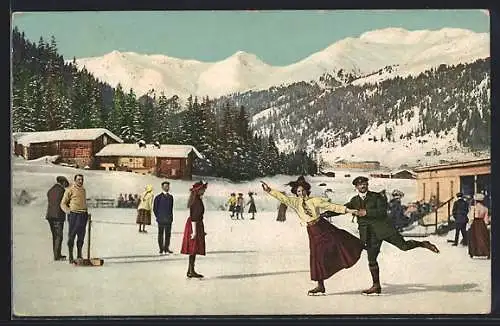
<box><xmin>262</xmin><ymin>176</ymin><xmax>363</xmax><ymax>295</ymax></box>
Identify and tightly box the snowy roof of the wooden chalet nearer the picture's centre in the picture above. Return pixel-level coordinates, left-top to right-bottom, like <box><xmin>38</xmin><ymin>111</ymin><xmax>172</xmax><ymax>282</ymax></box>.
<box><xmin>96</xmin><ymin>144</ymin><xmax>203</xmax><ymax>158</ymax></box>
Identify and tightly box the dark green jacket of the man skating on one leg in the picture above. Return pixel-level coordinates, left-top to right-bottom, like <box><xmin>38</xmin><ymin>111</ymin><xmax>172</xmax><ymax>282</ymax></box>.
<box><xmin>345</xmin><ymin>191</ymin><xmax>398</xmax><ymax>242</ymax></box>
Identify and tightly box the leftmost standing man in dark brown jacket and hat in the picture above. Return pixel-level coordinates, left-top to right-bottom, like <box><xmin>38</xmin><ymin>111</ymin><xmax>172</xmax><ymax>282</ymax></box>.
<box><xmin>45</xmin><ymin>176</ymin><xmax>69</xmax><ymax>261</ymax></box>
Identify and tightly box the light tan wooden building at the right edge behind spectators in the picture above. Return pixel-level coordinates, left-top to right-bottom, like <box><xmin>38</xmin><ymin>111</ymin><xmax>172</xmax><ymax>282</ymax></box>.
<box><xmin>414</xmin><ymin>158</ymin><xmax>491</xmax><ymax>223</ymax></box>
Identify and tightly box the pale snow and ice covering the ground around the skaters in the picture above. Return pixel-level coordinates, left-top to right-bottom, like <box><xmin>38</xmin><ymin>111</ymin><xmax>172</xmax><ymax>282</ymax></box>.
<box><xmin>12</xmin><ymin>158</ymin><xmax>491</xmax><ymax>316</ymax></box>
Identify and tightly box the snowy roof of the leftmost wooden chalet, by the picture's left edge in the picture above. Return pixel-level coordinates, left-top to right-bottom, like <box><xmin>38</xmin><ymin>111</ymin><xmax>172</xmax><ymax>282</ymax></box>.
<box><xmin>12</xmin><ymin>128</ymin><xmax>123</xmax><ymax>146</ymax></box>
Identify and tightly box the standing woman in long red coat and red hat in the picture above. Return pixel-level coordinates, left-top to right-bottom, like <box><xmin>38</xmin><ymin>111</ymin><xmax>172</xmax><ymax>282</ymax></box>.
<box><xmin>181</xmin><ymin>181</ymin><xmax>208</xmax><ymax>278</ymax></box>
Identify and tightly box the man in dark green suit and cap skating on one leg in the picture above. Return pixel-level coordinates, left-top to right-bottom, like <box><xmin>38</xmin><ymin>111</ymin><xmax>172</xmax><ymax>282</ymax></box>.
<box><xmin>345</xmin><ymin>177</ymin><xmax>439</xmax><ymax>295</ymax></box>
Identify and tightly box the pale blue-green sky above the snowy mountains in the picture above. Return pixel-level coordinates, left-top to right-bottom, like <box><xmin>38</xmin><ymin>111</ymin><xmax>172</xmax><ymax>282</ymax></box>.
<box><xmin>12</xmin><ymin>9</ymin><xmax>490</xmax><ymax>66</ymax></box>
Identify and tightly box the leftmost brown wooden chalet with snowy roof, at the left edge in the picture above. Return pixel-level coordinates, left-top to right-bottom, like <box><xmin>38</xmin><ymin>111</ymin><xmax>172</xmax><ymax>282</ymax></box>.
<box><xmin>13</xmin><ymin>128</ymin><xmax>123</xmax><ymax>168</ymax></box>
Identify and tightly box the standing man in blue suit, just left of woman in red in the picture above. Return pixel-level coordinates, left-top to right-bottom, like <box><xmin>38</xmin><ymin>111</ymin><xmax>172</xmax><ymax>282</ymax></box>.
<box><xmin>153</xmin><ymin>181</ymin><xmax>174</xmax><ymax>255</ymax></box>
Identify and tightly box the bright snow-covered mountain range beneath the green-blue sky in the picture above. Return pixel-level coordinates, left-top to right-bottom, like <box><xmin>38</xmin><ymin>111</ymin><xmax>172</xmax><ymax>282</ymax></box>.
<box><xmin>70</xmin><ymin>28</ymin><xmax>490</xmax><ymax>98</ymax></box>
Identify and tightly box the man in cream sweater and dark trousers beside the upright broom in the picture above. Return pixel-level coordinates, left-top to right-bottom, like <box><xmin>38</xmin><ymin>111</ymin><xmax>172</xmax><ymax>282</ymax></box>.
<box><xmin>61</xmin><ymin>174</ymin><xmax>88</xmax><ymax>263</ymax></box>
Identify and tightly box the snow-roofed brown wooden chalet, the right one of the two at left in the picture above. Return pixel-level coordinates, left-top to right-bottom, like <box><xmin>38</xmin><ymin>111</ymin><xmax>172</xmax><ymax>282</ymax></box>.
<box><xmin>96</xmin><ymin>144</ymin><xmax>203</xmax><ymax>180</ymax></box>
